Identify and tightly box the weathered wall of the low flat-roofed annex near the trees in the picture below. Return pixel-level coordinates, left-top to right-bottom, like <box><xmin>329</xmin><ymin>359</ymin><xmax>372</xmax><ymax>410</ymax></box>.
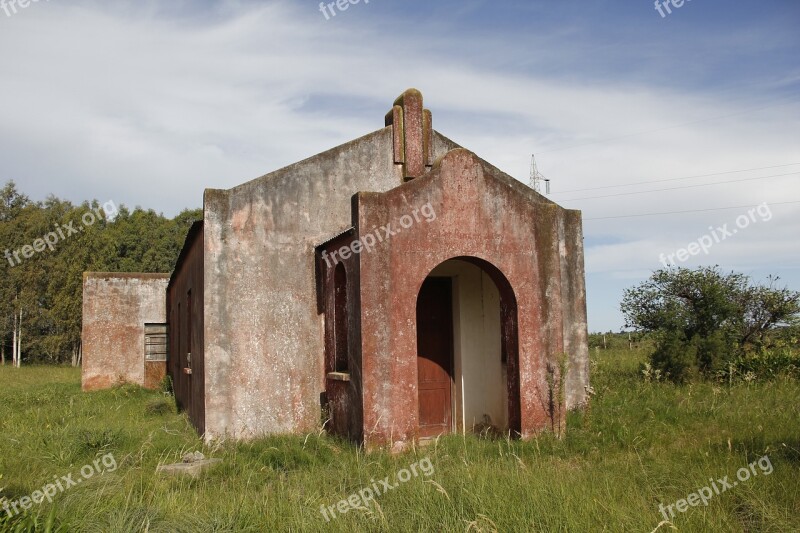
<box><xmin>81</xmin><ymin>272</ymin><xmax>169</xmax><ymax>391</ymax></box>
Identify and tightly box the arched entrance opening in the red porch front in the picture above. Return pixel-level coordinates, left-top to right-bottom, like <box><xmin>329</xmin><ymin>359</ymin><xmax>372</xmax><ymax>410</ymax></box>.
<box><xmin>416</xmin><ymin>257</ymin><xmax>520</xmax><ymax>439</ymax></box>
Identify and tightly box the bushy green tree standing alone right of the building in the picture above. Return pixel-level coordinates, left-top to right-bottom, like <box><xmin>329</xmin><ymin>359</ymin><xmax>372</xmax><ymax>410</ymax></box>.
<box><xmin>620</xmin><ymin>267</ymin><xmax>800</xmax><ymax>382</ymax></box>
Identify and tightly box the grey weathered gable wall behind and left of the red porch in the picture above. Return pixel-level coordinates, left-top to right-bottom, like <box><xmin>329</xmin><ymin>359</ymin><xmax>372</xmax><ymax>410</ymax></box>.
<box><xmin>204</xmin><ymin>127</ymin><xmax>455</xmax><ymax>438</ymax></box>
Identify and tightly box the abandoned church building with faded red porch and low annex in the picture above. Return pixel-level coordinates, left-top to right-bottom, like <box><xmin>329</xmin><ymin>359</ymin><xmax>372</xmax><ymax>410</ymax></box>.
<box><xmin>83</xmin><ymin>89</ymin><xmax>589</xmax><ymax>449</ymax></box>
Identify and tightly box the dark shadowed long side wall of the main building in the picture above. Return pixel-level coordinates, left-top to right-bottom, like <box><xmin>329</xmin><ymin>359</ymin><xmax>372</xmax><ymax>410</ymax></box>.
<box><xmin>166</xmin><ymin>222</ymin><xmax>205</xmax><ymax>434</ymax></box>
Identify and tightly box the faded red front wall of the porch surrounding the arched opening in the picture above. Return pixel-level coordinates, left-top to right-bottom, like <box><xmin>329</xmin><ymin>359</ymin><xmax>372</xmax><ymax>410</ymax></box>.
<box><xmin>355</xmin><ymin>149</ymin><xmax>588</xmax><ymax>447</ymax></box>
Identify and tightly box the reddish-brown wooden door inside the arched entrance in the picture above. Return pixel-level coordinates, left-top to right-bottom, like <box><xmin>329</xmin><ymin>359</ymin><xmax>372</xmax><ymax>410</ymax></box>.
<box><xmin>417</xmin><ymin>278</ymin><xmax>453</xmax><ymax>437</ymax></box>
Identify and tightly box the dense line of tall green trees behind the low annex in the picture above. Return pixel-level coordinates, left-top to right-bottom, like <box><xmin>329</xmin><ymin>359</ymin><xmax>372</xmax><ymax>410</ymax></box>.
<box><xmin>0</xmin><ymin>181</ymin><xmax>203</xmax><ymax>366</ymax></box>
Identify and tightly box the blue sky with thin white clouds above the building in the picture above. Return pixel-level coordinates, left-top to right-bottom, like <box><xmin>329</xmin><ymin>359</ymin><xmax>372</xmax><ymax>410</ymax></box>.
<box><xmin>0</xmin><ymin>0</ymin><xmax>800</xmax><ymax>331</ymax></box>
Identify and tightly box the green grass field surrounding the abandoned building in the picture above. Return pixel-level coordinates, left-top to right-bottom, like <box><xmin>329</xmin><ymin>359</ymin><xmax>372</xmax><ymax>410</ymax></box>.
<box><xmin>0</xmin><ymin>350</ymin><xmax>800</xmax><ymax>533</ymax></box>
